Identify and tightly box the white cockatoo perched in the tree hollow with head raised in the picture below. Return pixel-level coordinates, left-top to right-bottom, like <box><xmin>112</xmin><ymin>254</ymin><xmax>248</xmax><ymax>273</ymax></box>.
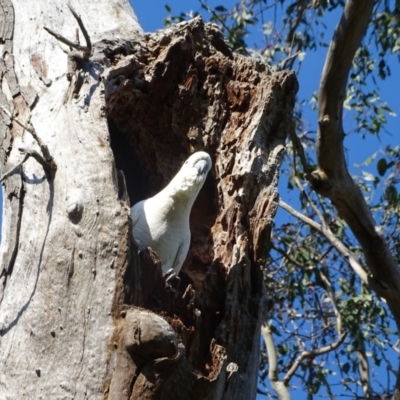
<box><xmin>131</xmin><ymin>151</ymin><xmax>212</xmax><ymax>279</ymax></box>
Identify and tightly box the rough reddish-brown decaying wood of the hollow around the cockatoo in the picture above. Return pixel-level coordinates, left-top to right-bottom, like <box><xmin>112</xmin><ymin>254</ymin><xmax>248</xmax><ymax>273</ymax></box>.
<box><xmin>103</xmin><ymin>19</ymin><xmax>297</xmax><ymax>399</ymax></box>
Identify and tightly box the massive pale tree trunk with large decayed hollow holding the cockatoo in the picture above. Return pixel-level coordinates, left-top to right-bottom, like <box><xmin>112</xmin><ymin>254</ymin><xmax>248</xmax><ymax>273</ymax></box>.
<box><xmin>0</xmin><ymin>0</ymin><xmax>297</xmax><ymax>399</ymax></box>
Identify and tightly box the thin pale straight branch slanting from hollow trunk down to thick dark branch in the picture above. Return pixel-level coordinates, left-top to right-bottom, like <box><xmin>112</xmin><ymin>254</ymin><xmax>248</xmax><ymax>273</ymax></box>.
<box><xmin>279</xmin><ymin>200</ymin><xmax>369</xmax><ymax>285</ymax></box>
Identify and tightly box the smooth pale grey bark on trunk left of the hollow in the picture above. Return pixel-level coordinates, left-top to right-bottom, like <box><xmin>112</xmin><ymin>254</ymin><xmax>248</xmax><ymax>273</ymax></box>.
<box><xmin>0</xmin><ymin>0</ymin><xmax>141</xmax><ymax>399</ymax></box>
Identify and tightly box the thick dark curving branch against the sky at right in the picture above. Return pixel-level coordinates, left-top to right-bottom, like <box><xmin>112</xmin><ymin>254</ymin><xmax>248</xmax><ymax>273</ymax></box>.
<box><xmin>312</xmin><ymin>0</ymin><xmax>400</xmax><ymax>324</ymax></box>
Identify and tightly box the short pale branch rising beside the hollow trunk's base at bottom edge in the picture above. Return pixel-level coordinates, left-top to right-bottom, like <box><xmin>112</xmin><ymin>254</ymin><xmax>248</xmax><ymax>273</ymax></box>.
<box><xmin>261</xmin><ymin>322</ymin><xmax>291</xmax><ymax>400</ymax></box>
